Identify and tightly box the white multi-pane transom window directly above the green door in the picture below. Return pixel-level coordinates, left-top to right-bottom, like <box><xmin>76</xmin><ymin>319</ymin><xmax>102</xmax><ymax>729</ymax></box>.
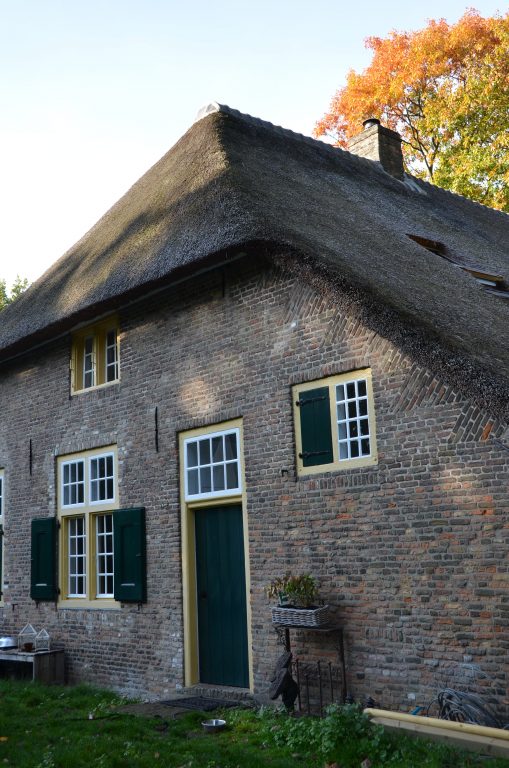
<box><xmin>184</xmin><ymin>429</ymin><xmax>242</xmax><ymax>499</ymax></box>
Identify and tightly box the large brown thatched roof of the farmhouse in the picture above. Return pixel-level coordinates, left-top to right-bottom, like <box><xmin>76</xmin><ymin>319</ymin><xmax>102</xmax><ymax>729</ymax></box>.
<box><xmin>0</xmin><ymin>105</ymin><xmax>509</xmax><ymax>400</ymax></box>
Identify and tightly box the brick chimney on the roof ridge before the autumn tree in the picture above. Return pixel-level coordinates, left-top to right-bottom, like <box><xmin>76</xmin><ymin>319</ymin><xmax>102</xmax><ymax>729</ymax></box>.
<box><xmin>348</xmin><ymin>117</ymin><xmax>404</xmax><ymax>181</ymax></box>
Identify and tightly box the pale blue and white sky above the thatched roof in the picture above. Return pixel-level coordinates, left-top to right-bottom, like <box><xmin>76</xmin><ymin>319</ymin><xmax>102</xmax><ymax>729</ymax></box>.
<box><xmin>0</xmin><ymin>0</ymin><xmax>508</xmax><ymax>286</ymax></box>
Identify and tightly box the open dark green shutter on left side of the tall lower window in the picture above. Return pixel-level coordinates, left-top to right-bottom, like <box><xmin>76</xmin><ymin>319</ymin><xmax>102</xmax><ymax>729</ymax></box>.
<box><xmin>30</xmin><ymin>517</ymin><xmax>57</xmax><ymax>600</ymax></box>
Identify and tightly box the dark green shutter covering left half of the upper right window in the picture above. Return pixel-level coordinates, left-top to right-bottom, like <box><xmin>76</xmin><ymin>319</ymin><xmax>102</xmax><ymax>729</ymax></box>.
<box><xmin>298</xmin><ymin>387</ymin><xmax>333</xmax><ymax>467</ymax></box>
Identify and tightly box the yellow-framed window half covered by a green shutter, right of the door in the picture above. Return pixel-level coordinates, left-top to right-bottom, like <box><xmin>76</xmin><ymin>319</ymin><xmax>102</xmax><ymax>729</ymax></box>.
<box><xmin>292</xmin><ymin>368</ymin><xmax>378</xmax><ymax>475</ymax></box>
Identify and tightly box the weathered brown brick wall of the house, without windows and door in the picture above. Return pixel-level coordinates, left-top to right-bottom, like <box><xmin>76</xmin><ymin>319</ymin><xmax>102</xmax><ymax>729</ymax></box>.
<box><xmin>0</xmin><ymin>255</ymin><xmax>509</xmax><ymax>707</ymax></box>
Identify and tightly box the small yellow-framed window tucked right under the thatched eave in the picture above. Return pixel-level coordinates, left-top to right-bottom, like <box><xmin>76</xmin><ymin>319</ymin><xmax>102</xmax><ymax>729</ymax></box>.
<box><xmin>71</xmin><ymin>318</ymin><xmax>119</xmax><ymax>392</ymax></box>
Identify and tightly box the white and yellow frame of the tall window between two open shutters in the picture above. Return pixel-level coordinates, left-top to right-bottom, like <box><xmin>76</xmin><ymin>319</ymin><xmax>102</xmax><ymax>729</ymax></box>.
<box><xmin>57</xmin><ymin>446</ymin><xmax>118</xmax><ymax>607</ymax></box>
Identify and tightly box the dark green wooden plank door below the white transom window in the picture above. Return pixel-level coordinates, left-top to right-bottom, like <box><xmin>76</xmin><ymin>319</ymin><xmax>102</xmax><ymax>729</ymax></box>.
<box><xmin>195</xmin><ymin>506</ymin><xmax>249</xmax><ymax>688</ymax></box>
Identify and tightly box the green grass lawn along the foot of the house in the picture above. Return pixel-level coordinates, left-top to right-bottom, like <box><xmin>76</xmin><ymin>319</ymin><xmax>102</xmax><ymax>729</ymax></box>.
<box><xmin>0</xmin><ymin>680</ymin><xmax>509</xmax><ymax>768</ymax></box>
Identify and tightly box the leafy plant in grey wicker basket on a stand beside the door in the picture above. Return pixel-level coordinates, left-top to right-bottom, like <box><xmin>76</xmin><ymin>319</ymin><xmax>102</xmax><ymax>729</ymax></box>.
<box><xmin>265</xmin><ymin>571</ymin><xmax>329</xmax><ymax>627</ymax></box>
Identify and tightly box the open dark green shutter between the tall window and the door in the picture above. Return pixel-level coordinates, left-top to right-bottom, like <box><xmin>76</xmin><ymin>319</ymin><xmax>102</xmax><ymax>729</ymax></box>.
<box><xmin>113</xmin><ymin>507</ymin><xmax>146</xmax><ymax>603</ymax></box>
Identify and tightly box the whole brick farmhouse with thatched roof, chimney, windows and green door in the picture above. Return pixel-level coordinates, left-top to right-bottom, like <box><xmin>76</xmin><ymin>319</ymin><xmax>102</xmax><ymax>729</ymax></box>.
<box><xmin>0</xmin><ymin>104</ymin><xmax>509</xmax><ymax>707</ymax></box>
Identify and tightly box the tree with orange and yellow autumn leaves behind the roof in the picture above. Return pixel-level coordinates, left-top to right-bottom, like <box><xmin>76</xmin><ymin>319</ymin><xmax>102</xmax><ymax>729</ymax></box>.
<box><xmin>315</xmin><ymin>10</ymin><xmax>509</xmax><ymax>212</ymax></box>
